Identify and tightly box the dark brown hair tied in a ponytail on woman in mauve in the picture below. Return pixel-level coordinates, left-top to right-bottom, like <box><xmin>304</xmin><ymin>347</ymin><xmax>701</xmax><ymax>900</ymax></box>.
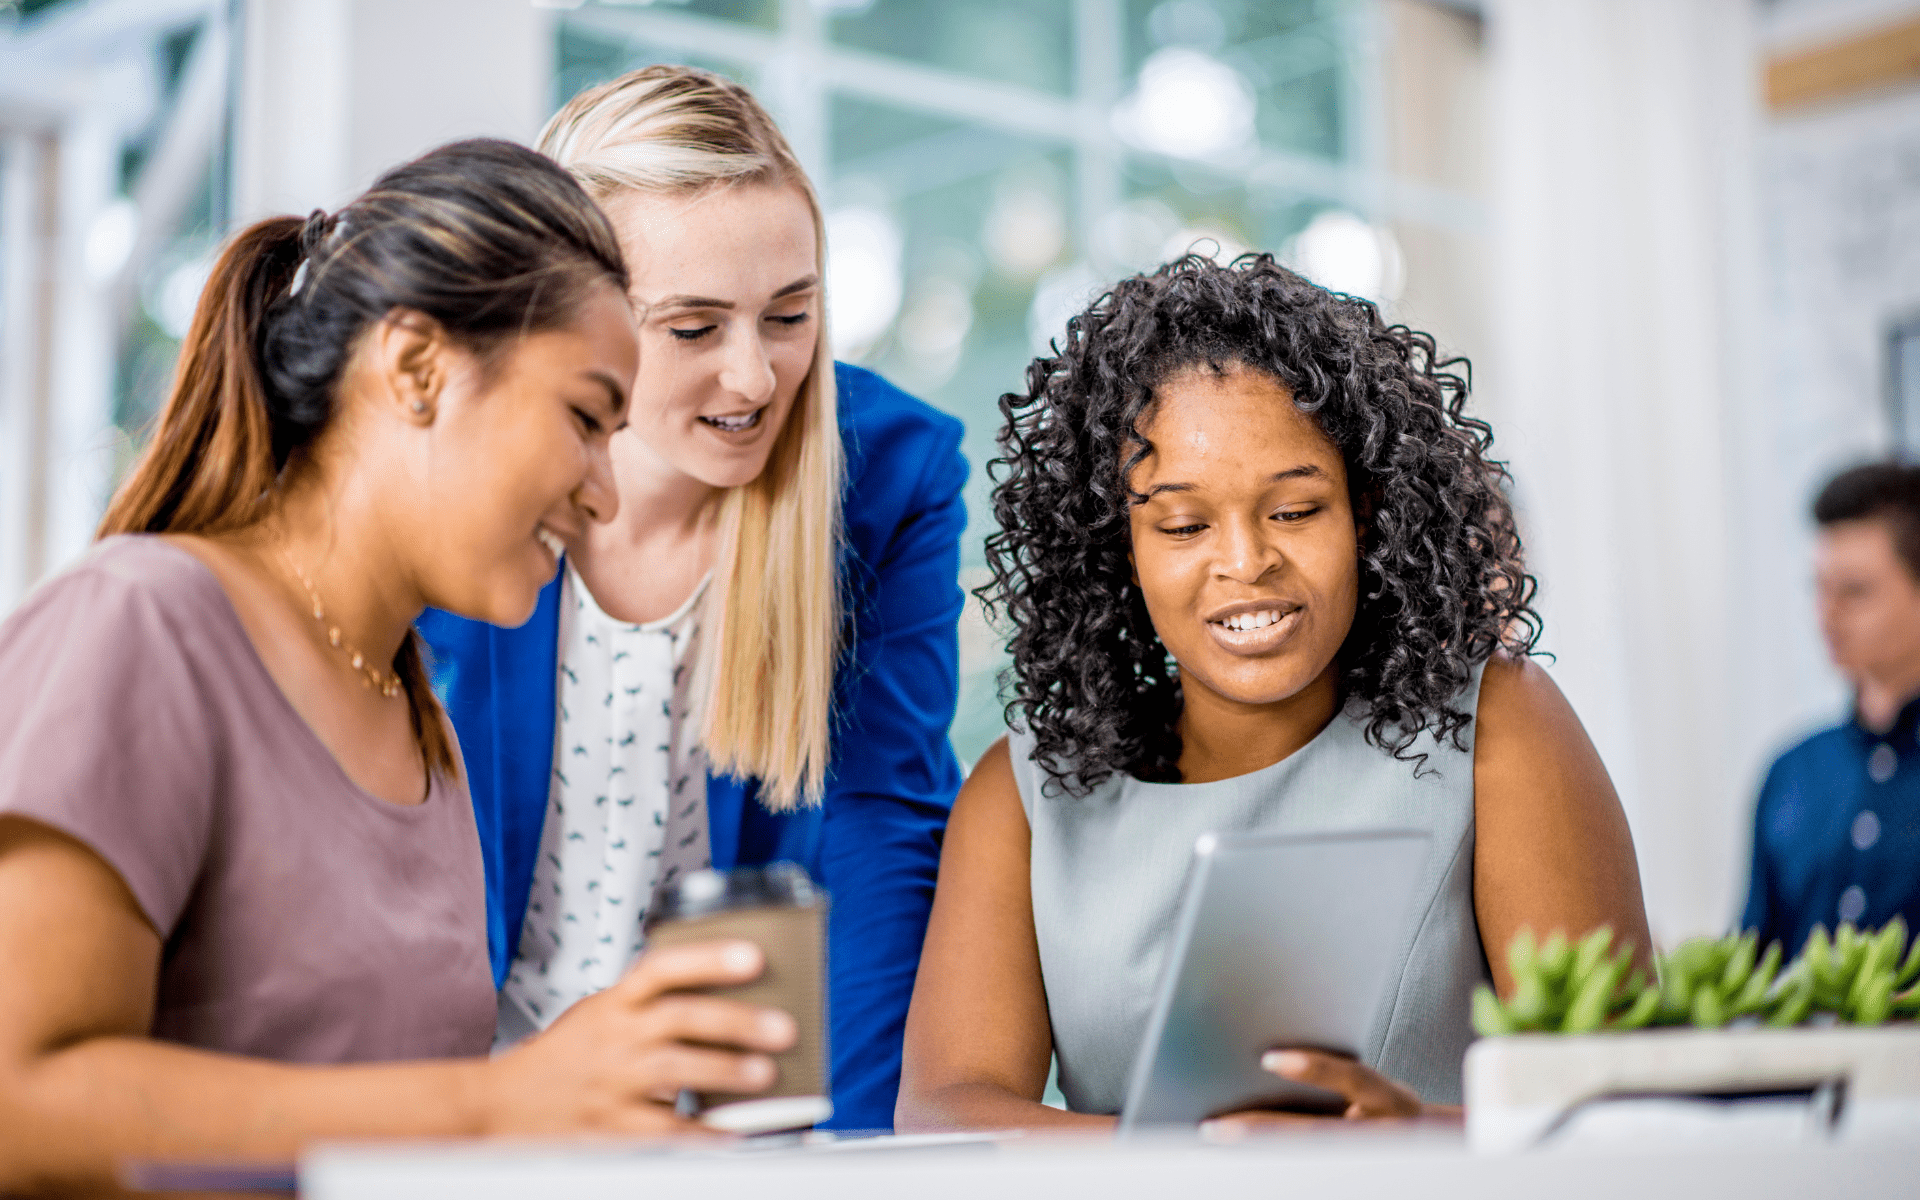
<box><xmin>96</xmin><ymin>138</ymin><xmax>628</xmax><ymax>776</ymax></box>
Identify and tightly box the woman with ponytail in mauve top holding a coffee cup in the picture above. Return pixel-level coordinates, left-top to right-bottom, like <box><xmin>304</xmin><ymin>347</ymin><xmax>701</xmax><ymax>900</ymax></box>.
<box><xmin>0</xmin><ymin>142</ymin><xmax>791</xmax><ymax>1194</ymax></box>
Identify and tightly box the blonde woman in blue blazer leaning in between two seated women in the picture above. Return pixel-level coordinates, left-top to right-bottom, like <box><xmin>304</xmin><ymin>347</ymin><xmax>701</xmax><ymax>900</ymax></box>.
<box><xmin>420</xmin><ymin>67</ymin><xmax>966</xmax><ymax>1129</ymax></box>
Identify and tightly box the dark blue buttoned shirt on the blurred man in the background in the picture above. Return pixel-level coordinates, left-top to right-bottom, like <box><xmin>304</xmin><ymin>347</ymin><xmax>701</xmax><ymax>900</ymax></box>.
<box><xmin>1741</xmin><ymin>699</ymin><xmax>1920</xmax><ymax>956</ymax></box>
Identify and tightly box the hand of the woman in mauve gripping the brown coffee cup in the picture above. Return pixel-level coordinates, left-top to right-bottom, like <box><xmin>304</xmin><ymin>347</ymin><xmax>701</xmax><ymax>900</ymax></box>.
<box><xmin>476</xmin><ymin>937</ymin><xmax>797</xmax><ymax>1137</ymax></box>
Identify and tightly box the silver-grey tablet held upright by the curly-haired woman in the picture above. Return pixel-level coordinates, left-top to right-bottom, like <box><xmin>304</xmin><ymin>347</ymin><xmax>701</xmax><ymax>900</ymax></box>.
<box><xmin>1119</xmin><ymin>829</ymin><xmax>1428</xmax><ymax>1133</ymax></box>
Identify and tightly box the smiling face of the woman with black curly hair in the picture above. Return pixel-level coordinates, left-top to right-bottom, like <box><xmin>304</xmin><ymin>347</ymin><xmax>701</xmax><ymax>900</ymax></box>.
<box><xmin>1127</xmin><ymin>365</ymin><xmax>1359</xmax><ymax>707</ymax></box>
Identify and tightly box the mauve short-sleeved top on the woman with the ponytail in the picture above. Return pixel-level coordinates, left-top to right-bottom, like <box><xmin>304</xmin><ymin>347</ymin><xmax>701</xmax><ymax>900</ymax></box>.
<box><xmin>0</xmin><ymin>536</ymin><xmax>495</xmax><ymax>1062</ymax></box>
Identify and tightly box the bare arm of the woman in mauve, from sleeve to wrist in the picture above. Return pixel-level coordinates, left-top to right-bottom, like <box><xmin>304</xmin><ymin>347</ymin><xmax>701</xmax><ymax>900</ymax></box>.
<box><xmin>0</xmin><ymin>818</ymin><xmax>486</xmax><ymax>1194</ymax></box>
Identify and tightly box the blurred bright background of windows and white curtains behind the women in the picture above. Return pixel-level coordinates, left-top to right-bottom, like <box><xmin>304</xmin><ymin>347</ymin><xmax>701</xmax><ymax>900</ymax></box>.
<box><xmin>0</xmin><ymin>0</ymin><xmax>1920</xmax><ymax>941</ymax></box>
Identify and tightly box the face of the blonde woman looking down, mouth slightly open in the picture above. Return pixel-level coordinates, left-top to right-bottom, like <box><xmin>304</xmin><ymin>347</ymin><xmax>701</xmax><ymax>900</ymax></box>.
<box><xmin>601</xmin><ymin>184</ymin><xmax>820</xmax><ymax>488</ymax></box>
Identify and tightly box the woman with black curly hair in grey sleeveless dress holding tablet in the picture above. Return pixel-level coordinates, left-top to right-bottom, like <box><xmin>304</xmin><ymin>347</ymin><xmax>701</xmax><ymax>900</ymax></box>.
<box><xmin>897</xmin><ymin>255</ymin><xmax>1647</xmax><ymax>1127</ymax></box>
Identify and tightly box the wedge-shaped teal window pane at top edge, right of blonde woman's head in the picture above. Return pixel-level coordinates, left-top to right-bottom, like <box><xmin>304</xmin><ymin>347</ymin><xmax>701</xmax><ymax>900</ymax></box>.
<box><xmin>829</xmin><ymin>0</ymin><xmax>1073</xmax><ymax>96</ymax></box>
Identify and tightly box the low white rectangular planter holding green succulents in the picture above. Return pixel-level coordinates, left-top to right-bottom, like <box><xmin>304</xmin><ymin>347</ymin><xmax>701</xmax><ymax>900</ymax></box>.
<box><xmin>1465</xmin><ymin>1021</ymin><xmax>1920</xmax><ymax>1152</ymax></box>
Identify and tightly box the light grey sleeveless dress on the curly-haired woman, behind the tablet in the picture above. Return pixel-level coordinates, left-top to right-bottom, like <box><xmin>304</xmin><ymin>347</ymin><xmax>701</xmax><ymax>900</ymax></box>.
<box><xmin>1008</xmin><ymin>670</ymin><xmax>1488</xmax><ymax>1114</ymax></box>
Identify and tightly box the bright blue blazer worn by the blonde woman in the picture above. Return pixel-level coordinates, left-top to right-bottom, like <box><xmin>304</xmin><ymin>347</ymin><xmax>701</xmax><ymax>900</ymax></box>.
<box><xmin>419</xmin><ymin>363</ymin><xmax>968</xmax><ymax>1129</ymax></box>
